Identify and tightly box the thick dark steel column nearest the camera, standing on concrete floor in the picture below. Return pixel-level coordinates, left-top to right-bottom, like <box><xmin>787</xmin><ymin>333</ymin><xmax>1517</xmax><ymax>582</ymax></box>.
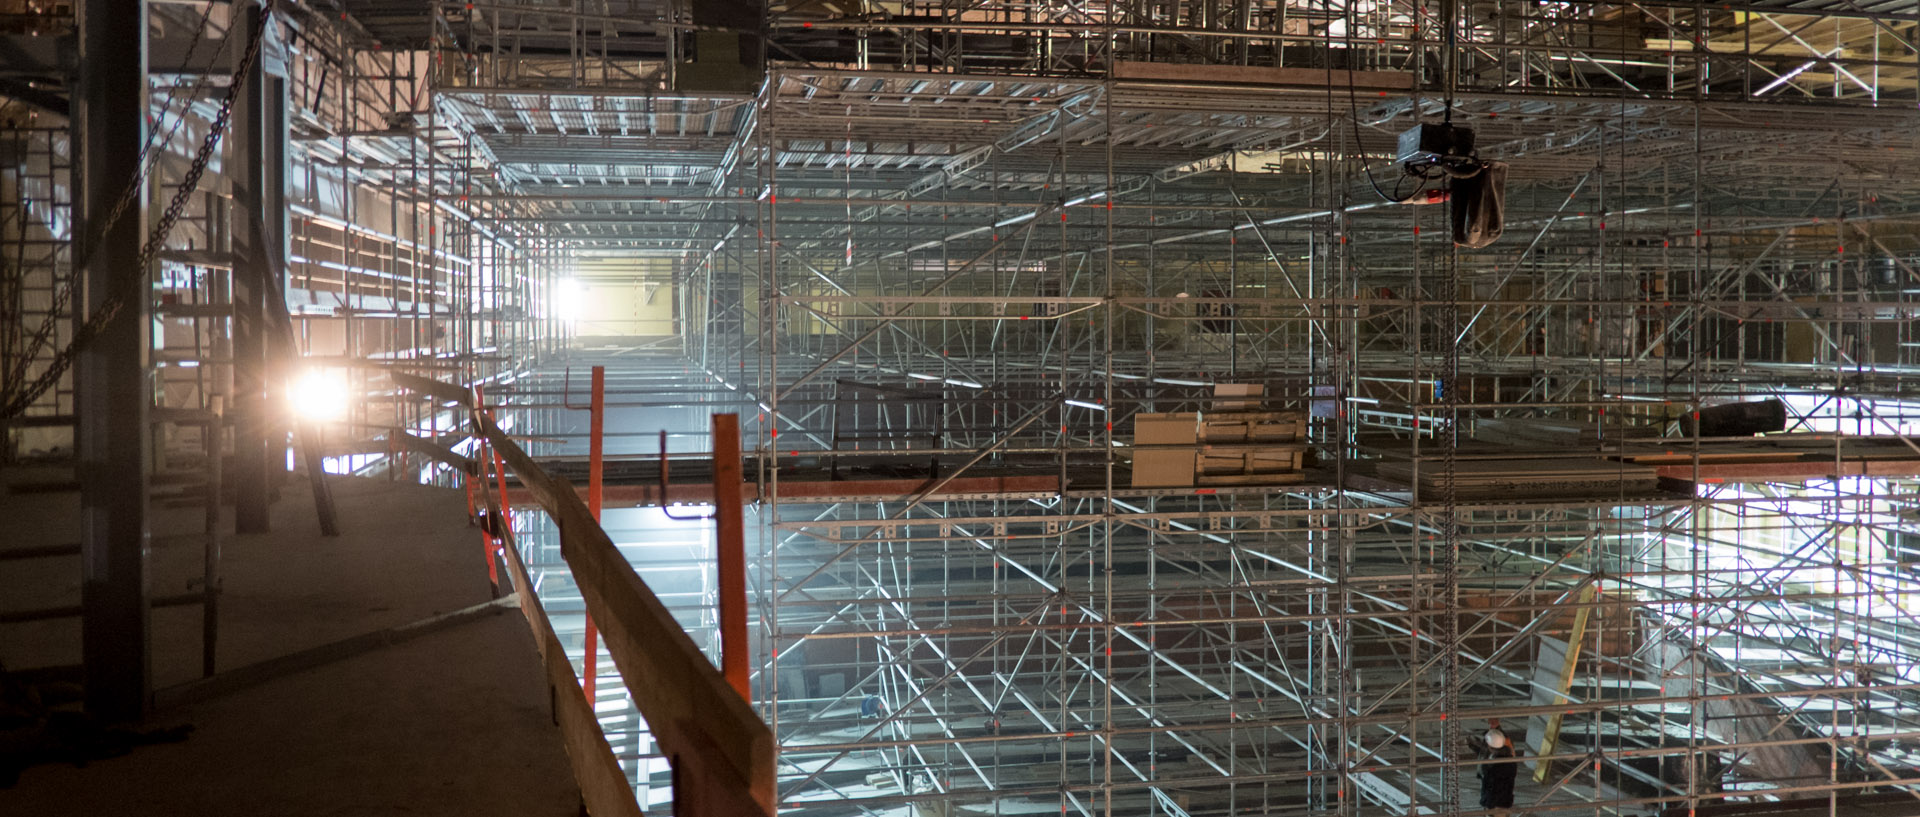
<box><xmin>75</xmin><ymin>0</ymin><xmax>154</xmax><ymax>723</ymax></box>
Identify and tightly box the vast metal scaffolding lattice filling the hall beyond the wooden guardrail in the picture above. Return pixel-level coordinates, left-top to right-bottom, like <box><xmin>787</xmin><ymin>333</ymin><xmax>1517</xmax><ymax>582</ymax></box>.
<box><xmin>11</xmin><ymin>0</ymin><xmax>1920</xmax><ymax>817</ymax></box>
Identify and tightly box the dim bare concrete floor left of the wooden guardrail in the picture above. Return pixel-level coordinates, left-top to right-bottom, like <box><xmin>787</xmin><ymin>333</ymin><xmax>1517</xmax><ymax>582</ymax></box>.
<box><xmin>0</xmin><ymin>470</ymin><xmax>580</xmax><ymax>815</ymax></box>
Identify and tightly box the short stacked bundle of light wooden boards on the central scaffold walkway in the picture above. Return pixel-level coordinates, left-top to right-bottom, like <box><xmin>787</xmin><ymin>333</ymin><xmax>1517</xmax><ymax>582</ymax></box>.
<box><xmin>1133</xmin><ymin>385</ymin><xmax>1308</xmax><ymax>487</ymax></box>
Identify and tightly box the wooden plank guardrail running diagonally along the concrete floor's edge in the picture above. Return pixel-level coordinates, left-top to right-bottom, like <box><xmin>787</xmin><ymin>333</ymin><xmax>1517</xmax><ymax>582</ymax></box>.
<box><xmin>392</xmin><ymin>372</ymin><xmax>776</xmax><ymax>817</ymax></box>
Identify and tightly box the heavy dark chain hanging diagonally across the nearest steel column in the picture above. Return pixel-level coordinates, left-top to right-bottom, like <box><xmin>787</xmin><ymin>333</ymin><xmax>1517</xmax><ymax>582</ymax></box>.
<box><xmin>0</xmin><ymin>0</ymin><xmax>275</xmax><ymax>418</ymax></box>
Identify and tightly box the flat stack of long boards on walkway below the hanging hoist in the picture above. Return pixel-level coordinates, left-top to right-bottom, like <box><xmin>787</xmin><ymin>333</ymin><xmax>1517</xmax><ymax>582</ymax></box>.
<box><xmin>1377</xmin><ymin>456</ymin><xmax>1659</xmax><ymax>501</ymax></box>
